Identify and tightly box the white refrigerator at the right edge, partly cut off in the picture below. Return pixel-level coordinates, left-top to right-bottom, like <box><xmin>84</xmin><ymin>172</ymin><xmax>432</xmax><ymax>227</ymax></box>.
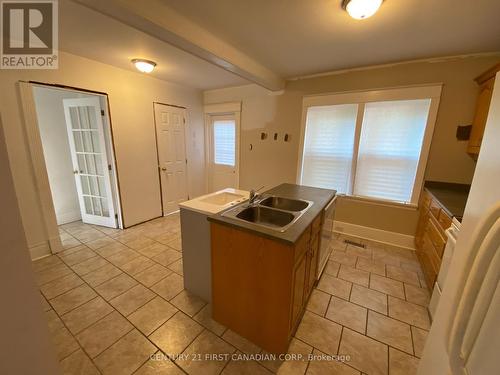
<box><xmin>418</xmin><ymin>73</ymin><xmax>500</xmax><ymax>375</ymax></box>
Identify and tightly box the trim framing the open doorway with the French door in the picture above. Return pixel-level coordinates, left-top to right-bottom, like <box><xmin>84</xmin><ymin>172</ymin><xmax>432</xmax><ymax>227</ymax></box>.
<box><xmin>17</xmin><ymin>80</ymin><xmax>124</xmax><ymax>254</ymax></box>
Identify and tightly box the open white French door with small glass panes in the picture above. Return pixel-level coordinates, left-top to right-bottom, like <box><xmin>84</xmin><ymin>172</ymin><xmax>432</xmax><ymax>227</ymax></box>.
<box><xmin>63</xmin><ymin>97</ymin><xmax>117</xmax><ymax>228</ymax></box>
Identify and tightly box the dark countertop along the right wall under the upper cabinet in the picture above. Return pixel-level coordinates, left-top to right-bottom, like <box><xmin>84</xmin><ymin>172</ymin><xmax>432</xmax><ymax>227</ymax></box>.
<box><xmin>424</xmin><ymin>181</ymin><xmax>470</xmax><ymax>221</ymax></box>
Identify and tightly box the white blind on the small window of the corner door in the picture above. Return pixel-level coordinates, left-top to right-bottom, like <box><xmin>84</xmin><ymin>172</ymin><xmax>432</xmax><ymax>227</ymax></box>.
<box><xmin>213</xmin><ymin>120</ymin><xmax>236</xmax><ymax>166</ymax></box>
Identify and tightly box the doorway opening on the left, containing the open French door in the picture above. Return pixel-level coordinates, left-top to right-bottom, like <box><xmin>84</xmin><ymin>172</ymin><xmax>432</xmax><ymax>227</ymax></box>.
<box><xmin>32</xmin><ymin>84</ymin><xmax>123</xmax><ymax>235</ymax></box>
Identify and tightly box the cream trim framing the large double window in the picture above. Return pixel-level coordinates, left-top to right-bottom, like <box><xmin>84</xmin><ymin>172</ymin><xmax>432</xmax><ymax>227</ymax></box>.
<box><xmin>296</xmin><ymin>83</ymin><xmax>443</xmax><ymax>207</ymax></box>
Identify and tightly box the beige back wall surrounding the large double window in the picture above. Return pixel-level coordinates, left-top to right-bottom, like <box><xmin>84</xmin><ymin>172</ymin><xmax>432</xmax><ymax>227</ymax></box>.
<box><xmin>204</xmin><ymin>56</ymin><xmax>500</xmax><ymax>235</ymax></box>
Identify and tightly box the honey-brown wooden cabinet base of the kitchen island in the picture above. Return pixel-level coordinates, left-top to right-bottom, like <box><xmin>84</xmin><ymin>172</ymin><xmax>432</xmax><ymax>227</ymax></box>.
<box><xmin>211</xmin><ymin>214</ymin><xmax>322</xmax><ymax>354</ymax></box>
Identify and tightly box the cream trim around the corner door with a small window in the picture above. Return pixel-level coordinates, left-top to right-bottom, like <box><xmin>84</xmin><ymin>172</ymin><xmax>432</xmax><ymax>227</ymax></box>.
<box><xmin>203</xmin><ymin>102</ymin><xmax>241</xmax><ymax>192</ymax></box>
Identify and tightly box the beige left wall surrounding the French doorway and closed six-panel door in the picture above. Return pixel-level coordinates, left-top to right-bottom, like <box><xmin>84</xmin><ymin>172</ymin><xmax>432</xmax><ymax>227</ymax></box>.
<box><xmin>0</xmin><ymin>52</ymin><xmax>205</xmax><ymax>258</ymax></box>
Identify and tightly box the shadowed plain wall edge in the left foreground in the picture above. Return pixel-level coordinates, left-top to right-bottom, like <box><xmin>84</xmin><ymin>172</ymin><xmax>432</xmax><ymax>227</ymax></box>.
<box><xmin>0</xmin><ymin>118</ymin><xmax>60</xmax><ymax>375</ymax></box>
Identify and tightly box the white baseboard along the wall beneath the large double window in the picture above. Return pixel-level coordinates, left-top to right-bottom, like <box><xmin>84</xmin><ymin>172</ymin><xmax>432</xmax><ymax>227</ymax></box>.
<box><xmin>333</xmin><ymin>221</ymin><xmax>415</xmax><ymax>251</ymax></box>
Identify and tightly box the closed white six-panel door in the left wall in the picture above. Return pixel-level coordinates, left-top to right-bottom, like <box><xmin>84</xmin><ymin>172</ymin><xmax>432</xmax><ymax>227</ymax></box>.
<box><xmin>154</xmin><ymin>103</ymin><xmax>188</xmax><ymax>215</ymax></box>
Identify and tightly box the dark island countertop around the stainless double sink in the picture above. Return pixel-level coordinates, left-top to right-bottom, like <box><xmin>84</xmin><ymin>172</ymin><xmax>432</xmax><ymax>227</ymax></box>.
<box><xmin>208</xmin><ymin>184</ymin><xmax>336</xmax><ymax>245</ymax></box>
